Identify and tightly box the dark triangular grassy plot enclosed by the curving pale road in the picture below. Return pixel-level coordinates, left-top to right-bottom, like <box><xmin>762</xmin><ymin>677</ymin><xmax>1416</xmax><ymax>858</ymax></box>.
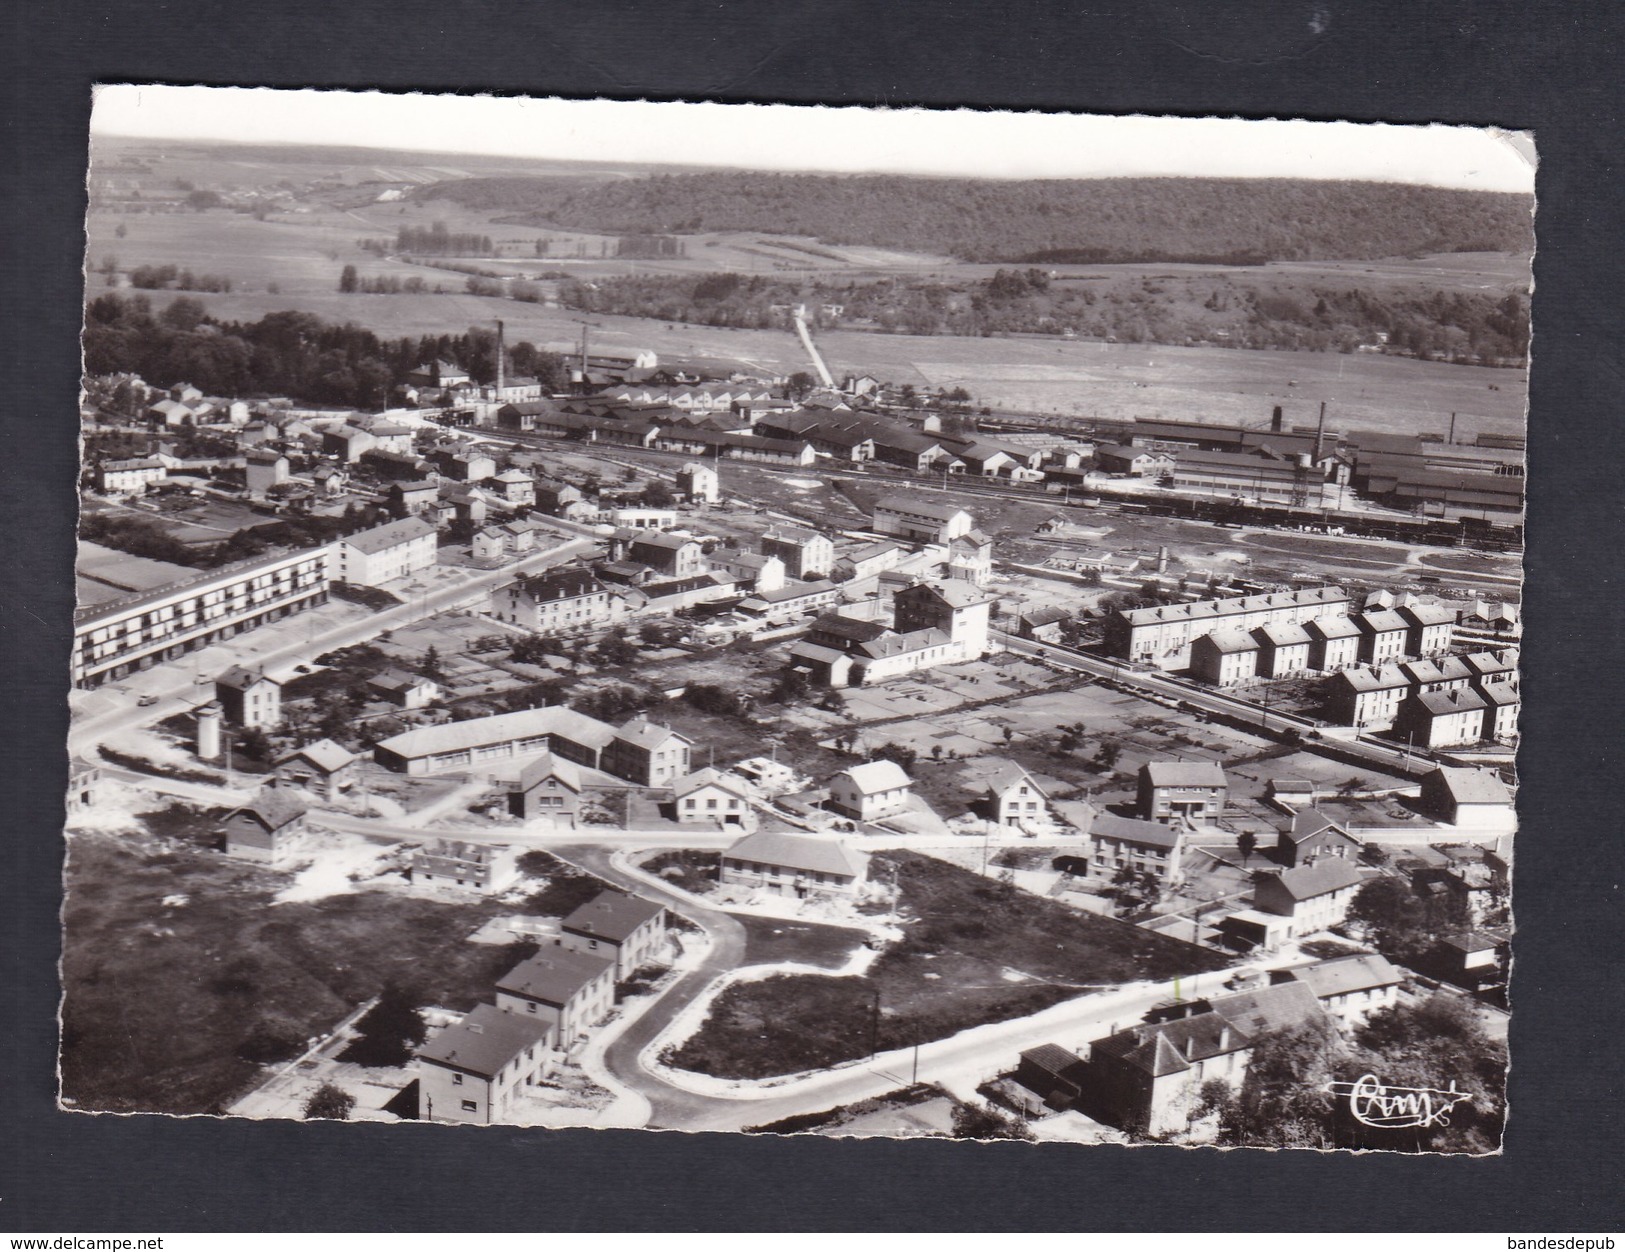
<box><xmin>668</xmin><ymin>852</ymin><xmax>1224</xmax><ymax>1078</ymax></box>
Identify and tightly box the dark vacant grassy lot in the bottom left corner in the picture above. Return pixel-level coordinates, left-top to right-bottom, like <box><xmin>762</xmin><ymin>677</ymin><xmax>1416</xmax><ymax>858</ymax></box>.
<box><xmin>62</xmin><ymin>834</ymin><xmax>530</xmax><ymax>1114</ymax></box>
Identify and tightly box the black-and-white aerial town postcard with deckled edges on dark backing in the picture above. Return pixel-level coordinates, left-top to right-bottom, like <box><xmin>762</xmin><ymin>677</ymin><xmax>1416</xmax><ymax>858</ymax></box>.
<box><xmin>60</xmin><ymin>85</ymin><xmax>1536</xmax><ymax>1154</ymax></box>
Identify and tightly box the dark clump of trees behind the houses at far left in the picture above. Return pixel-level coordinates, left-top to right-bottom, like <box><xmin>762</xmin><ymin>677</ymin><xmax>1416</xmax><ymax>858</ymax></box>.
<box><xmin>85</xmin><ymin>291</ymin><xmax>569</xmax><ymax>410</ymax></box>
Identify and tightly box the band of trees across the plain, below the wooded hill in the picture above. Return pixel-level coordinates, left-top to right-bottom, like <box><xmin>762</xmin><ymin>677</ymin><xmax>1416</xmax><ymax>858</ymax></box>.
<box><xmin>559</xmin><ymin>267</ymin><xmax>1529</xmax><ymax>364</ymax></box>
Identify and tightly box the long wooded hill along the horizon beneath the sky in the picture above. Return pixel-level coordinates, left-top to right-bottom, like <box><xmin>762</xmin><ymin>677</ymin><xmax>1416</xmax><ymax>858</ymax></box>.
<box><xmin>413</xmin><ymin>171</ymin><xmax>1534</xmax><ymax>265</ymax></box>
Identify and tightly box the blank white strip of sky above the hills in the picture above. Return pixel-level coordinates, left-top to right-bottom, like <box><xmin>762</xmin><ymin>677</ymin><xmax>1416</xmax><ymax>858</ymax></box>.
<box><xmin>91</xmin><ymin>85</ymin><xmax>1534</xmax><ymax>192</ymax></box>
